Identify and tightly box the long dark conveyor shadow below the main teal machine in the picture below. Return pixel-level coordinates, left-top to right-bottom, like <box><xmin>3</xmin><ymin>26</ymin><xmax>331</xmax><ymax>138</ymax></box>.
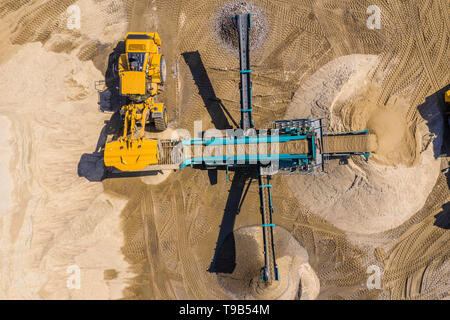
<box><xmin>208</xmin><ymin>168</ymin><xmax>255</xmax><ymax>273</ymax></box>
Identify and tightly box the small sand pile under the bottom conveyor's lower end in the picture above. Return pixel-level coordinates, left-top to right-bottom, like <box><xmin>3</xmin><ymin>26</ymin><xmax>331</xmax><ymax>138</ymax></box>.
<box><xmin>217</xmin><ymin>227</ymin><xmax>320</xmax><ymax>300</ymax></box>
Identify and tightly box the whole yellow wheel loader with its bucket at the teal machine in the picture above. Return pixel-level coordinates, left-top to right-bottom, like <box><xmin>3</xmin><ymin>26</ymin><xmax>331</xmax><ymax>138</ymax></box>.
<box><xmin>104</xmin><ymin>32</ymin><xmax>168</xmax><ymax>171</ymax></box>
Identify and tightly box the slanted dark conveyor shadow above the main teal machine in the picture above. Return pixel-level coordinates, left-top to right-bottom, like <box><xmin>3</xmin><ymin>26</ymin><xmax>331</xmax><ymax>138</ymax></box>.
<box><xmin>182</xmin><ymin>51</ymin><xmax>239</xmax><ymax>130</ymax></box>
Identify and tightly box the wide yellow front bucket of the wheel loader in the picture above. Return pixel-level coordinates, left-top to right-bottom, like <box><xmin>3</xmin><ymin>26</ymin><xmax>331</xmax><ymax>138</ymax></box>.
<box><xmin>104</xmin><ymin>139</ymin><xmax>159</xmax><ymax>171</ymax></box>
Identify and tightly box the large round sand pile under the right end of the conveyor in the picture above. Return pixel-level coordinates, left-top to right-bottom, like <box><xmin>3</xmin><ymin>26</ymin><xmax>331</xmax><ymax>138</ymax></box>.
<box><xmin>287</xmin><ymin>55</ymin><xmax>442</xmax><ymax>233</ymax></box>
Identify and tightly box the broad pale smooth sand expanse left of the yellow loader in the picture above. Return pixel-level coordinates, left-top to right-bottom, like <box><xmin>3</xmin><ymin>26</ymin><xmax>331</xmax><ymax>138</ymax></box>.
<box><xmin>0</xmin><ymin>43</ymin><xmax>141</xmax><ymax>299</ymax></box>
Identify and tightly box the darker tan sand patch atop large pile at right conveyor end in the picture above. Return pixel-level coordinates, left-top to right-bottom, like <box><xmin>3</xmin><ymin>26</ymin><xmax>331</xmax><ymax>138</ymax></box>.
<box><xmin>331</xmin><ymin>79</ymin><xmax>420</xmax><ymax>167</ymax></box>
